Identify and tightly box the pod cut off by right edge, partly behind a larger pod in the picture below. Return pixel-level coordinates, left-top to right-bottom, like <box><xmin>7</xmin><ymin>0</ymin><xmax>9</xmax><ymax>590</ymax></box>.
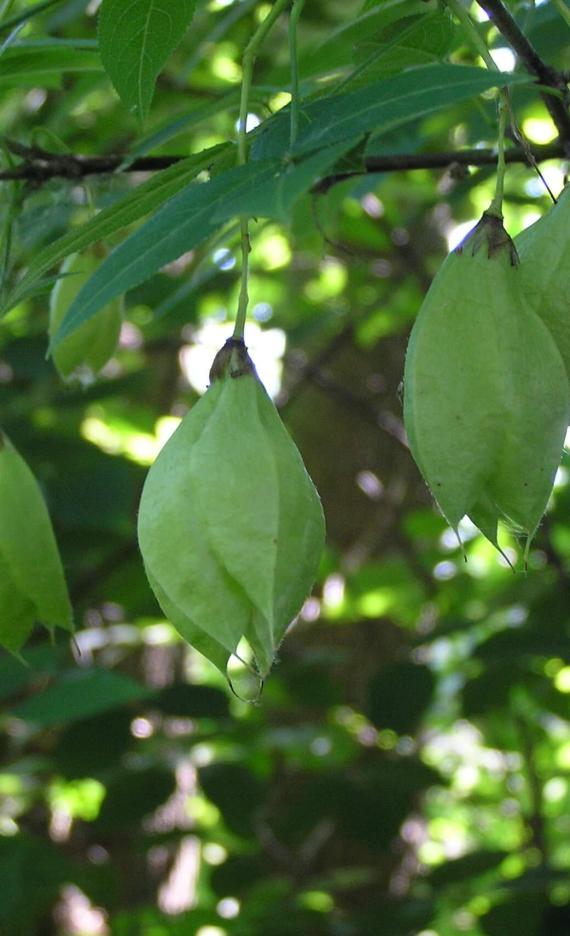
<box><xmin>515</xmin><ymin>185</ymin><xmax>570</xmax><ymax>374</ymax></box>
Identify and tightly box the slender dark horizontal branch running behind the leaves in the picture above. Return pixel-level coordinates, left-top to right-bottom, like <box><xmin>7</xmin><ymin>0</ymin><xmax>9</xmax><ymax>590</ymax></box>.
<box><xmin>0</xmin><ymin>143</ymin><xmax>565</xmax><ymax>192</ymax></box>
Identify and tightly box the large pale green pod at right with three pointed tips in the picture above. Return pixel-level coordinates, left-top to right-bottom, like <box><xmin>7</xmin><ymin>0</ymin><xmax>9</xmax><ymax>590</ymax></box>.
<box><xmin>404</xmin><ymin>214</ymin><xmax>570</xmax><ymax>560</ymax></box>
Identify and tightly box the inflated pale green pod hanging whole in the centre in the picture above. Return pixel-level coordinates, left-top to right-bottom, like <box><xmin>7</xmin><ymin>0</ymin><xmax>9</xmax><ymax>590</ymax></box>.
<box><xmin>138</xmin><ymin>339</ymin><xmax>325</xmax><ymax>692</ymax></box>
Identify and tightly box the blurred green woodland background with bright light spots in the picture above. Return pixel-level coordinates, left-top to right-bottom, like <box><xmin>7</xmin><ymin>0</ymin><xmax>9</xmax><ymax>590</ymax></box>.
<box><xmin>0</xmin><ymin>0</ymin><xmax>570</xmax><ymax>936</ymax></box>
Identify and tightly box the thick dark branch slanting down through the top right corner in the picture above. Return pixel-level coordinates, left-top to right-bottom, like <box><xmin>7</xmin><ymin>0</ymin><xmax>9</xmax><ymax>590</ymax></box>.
<box><xmin>477</xmin><ymin>0</ymin><xmax>570</xmax><ymax>144</ymax></box>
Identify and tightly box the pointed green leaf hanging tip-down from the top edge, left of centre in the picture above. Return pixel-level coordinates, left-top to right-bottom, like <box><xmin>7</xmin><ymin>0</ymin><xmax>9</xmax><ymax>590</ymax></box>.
<box><xmin>98</xmin><ymin>0</ymin><xmax>199</xmax><ymax>121</ymax></box>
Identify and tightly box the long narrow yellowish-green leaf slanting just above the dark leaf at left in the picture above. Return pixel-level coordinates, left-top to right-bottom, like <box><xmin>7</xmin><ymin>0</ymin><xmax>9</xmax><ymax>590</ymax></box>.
<box><xmin>3</xmin><ymin>143</ymin><xmax>228</xmax><ymax>312</ymax></box>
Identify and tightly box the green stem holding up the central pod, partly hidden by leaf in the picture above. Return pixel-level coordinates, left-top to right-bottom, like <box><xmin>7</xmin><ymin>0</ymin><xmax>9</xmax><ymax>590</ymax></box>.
<box><xmin>233</xmin><ymin>0</ymin><xmax>291</xmax><ymax>339</ymax></box>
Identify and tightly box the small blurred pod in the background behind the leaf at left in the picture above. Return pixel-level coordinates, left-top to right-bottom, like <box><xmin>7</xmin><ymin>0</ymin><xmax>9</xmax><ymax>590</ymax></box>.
<box><xmin>49</xmin><ymin>250</ymin><xmax>123</xmax><ymax>383</ymax></box>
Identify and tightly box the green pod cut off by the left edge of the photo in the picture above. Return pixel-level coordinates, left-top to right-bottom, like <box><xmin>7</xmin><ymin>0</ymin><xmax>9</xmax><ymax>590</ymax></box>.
<box><xmin>0</xmin><ymin>432</ymin><xmax>73</xmax><ymax>653</ymax></box>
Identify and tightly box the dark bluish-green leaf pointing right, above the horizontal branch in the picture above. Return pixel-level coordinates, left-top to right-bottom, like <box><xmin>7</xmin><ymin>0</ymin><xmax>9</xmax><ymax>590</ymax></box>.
<box><xmin>252</xmin><ymin>65</ymin><xmax>530</xmax><ymax>159</ymax></box>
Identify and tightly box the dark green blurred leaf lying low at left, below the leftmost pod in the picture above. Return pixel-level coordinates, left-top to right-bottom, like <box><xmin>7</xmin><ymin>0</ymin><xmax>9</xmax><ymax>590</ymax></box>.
<box><xmin>10</xmin><ymin>667</ymin><xmax>152</xmax><ymax>728</ymax></box>
